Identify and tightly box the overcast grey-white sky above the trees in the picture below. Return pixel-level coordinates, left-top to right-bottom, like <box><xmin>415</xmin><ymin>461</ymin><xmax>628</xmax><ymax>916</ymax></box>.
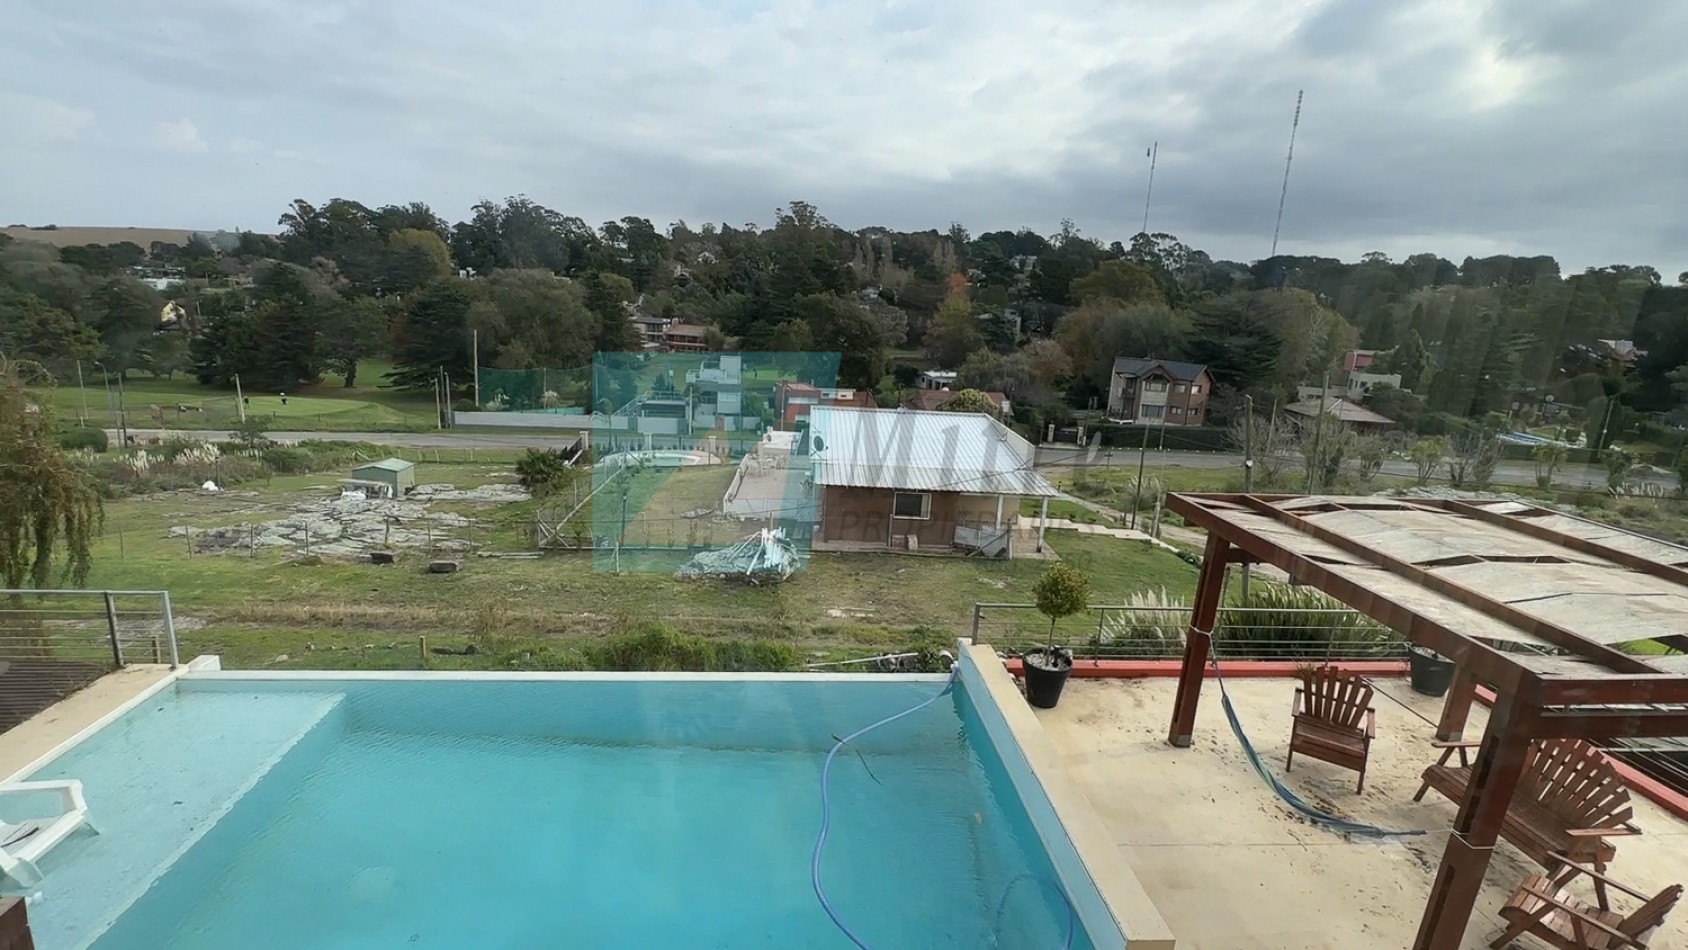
<box><xmin>0</xmin><ymin>0</ymin><xmax>1688</xmax><ymax>282</ymax></box>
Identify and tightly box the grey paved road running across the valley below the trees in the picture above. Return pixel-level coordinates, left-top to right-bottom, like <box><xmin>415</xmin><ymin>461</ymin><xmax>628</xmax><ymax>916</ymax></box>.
<box><xmin>108</xmin><ymin>429</ymin><xmax>1640</xmax><ymax>488</ymax></box>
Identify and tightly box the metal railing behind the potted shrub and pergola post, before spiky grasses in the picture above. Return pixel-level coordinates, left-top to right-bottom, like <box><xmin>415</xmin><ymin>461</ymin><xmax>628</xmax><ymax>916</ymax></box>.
<box><xmin>972</xmin><ymin>604</ymin><xmax>1408</xmax><ymax>661</ymax></box>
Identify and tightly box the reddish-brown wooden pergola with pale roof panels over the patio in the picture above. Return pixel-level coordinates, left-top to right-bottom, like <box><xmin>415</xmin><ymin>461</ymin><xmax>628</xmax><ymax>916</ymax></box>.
<box><xmin>1166</xmin><ymin>494</ymin><xmax>1688</xmax><ymax>950</ymax></box>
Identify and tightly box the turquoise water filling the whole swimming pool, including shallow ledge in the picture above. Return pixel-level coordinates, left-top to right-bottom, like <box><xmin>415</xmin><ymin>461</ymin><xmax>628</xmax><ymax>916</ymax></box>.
<box><xmin>30</xmin><ymin>677</ymin><xmax>1094</xmax><ymax>950</ymax></box>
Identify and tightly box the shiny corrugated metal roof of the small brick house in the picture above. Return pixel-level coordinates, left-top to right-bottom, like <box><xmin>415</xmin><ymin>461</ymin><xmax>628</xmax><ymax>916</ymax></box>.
<box><xmin>809</xmin><ymin>405</ymin><xmax>1060</xmax><ymax>496</ymax></box>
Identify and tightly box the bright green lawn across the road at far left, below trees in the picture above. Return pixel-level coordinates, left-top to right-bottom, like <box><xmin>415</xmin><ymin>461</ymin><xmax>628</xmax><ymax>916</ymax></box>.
<box><xmin>38</xmin><ymin>363</ymin><xmax>434</xmax><ymax>432</ymax></box>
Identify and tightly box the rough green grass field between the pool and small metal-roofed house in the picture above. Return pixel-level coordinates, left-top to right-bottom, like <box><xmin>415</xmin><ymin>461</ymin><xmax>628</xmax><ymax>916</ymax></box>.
<box><xmin>72</xmin><ymin>461</ymin><xmax>1195</xmax><ymax>668</ymax></box>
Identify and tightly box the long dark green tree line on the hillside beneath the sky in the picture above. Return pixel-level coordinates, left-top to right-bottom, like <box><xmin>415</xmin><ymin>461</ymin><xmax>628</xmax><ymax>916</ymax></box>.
<box><xmin>0</xmin><ymin>196</ymin><xmax>1688</xmax><ymax>435</ymax></box>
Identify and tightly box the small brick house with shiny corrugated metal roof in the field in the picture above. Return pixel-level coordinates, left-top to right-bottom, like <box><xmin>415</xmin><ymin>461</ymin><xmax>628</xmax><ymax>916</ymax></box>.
<box><xmin>805</xmin><ymin>405</ymin><xmax>1058</xmax><ymax>555</ymax></box>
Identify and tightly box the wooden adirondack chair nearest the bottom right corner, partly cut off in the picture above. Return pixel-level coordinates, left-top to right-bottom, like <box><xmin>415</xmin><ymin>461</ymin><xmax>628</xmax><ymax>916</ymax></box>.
<box><xmin>1489</xmin><ymin>862</ymin><xmax>1683</xmax><ymax>950</ymax></box>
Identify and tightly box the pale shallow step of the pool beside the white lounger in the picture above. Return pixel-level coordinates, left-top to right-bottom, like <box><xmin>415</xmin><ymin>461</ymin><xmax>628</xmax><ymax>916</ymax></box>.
<box><xmin>29</xmin><ymin>692</ymin><xmax>344</xmax><ymax>947</ymax></box>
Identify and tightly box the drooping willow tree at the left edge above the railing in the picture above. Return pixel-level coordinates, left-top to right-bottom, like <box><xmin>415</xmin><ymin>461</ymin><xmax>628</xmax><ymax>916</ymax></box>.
<box><xmin>0</xmin><ymin>358</ymin><xmax>105</xmax><ymax>589</ymax></box>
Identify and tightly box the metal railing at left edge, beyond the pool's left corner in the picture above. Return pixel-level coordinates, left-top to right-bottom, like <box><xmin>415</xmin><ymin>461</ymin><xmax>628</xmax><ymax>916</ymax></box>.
<box><xmin>0</xmin><ymin>589</ymin><xmax>181</xmax><ymax>672</ymax></box>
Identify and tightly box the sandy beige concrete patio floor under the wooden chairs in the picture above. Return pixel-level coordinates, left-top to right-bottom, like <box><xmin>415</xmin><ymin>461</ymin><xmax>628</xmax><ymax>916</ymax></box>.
<box><xmin>1038</xmin><ymin>675</ymin><xmax>1688</xmax><ymax>950</ymax></box>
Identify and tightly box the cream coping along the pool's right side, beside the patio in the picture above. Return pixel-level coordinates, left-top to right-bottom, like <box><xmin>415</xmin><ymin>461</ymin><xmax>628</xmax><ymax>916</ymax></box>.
<box><xmin>957</xmin><ymin>638</ymin><xmax>1175</xmax><ymax>950</ymax></box>
